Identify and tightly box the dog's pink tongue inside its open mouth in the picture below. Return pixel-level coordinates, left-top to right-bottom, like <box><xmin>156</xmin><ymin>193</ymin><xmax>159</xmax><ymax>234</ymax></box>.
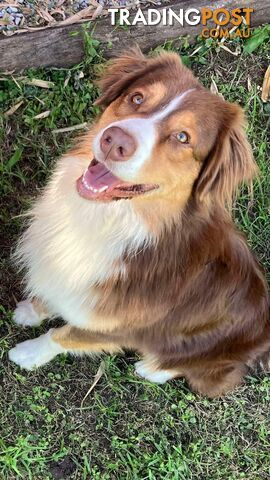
<box><xmin>83</xmin><ymin>163</ymin><xmax>121</xmax><ymax>191</ymax></box>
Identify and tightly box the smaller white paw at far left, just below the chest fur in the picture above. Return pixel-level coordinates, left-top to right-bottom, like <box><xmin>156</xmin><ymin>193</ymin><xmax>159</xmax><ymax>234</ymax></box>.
<box><xmin>13</xmin><ymin>298</ymin><xmax>52</xmax><ymax>327</ymax></box>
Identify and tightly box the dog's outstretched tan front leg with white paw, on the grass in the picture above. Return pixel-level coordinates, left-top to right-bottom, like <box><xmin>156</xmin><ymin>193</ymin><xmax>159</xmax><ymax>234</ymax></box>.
<box><xmin>9</xmin><ymin>325</ymin><xmax>121</xmax><ymax>370</ymax></box>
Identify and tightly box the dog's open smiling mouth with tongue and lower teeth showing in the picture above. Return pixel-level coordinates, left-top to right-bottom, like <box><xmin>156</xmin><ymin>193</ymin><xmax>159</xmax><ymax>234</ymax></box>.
<box><xmin>77</xmin><ymin>159</ymin><xmax>158</xmax><ymax>202</ymax></box>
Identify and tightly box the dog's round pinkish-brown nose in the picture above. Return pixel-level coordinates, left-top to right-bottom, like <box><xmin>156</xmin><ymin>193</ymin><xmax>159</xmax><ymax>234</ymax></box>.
<box><xmin>100</xmin><ymin>127</ymin><xmax>136</xmax><ymax>162</ymax></box>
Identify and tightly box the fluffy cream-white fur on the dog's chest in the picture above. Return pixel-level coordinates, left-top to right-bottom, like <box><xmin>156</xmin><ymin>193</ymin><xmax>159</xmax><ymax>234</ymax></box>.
<box><xmin>18</xmin><ymin>158</ymin><xmax>149</xmax><ymax>327</ymax></box>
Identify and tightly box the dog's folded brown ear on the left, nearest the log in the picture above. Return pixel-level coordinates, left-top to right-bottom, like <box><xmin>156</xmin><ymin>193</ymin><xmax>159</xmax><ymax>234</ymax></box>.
<box><xmin>95</xmin><ymin>48</ymin><xmax>147</xmax><ymax>107</ymax></box>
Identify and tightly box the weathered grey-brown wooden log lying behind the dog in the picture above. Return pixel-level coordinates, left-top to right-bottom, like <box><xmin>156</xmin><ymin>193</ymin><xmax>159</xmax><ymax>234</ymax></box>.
<box><xmin>0</xmin><ymin>0</ymin><xmax>270</xmax><ymax>71</ymax></box>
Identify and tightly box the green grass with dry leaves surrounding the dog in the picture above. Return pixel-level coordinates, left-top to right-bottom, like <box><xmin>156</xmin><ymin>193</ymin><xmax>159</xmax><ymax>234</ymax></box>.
<box><xmin>0</xmin><ymin>31</ymin><xmax>270</xmax><ymax>480</ymax></box>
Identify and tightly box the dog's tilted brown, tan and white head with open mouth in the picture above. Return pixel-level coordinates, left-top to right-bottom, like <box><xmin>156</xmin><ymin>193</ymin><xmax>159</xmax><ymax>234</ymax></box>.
<box><xmin>77</xmin><ymin>50</ymin><xmax>256</xmax><ymax>205</ymax></box>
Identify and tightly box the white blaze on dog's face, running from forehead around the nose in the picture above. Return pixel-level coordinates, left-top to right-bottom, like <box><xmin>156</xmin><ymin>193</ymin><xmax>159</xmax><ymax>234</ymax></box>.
<box><xmin>93</xmin><ymin>88</ymin><xmax>195</xmax><ymax>181</ymax></box>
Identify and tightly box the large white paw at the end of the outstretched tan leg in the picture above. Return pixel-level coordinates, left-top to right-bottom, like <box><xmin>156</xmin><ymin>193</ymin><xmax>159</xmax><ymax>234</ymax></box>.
<box><xmin>8</xmin><ymin>330</ymin><xmax>65</xmax><ymax>370</ymax></box>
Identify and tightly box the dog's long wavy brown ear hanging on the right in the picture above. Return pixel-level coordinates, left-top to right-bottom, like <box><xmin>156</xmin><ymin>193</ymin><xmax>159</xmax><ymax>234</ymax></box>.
<box><xmin>195</xmin><ymin>102</ymin><xmax>257</xmax><ymax>205</ymax></box>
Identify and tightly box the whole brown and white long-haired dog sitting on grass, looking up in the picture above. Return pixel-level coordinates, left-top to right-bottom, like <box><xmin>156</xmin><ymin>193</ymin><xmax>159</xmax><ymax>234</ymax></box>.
<box><xmin>9</xmin><ymin>50</ymin><xmax>270</xmax><ymax>397</ymax></box>
